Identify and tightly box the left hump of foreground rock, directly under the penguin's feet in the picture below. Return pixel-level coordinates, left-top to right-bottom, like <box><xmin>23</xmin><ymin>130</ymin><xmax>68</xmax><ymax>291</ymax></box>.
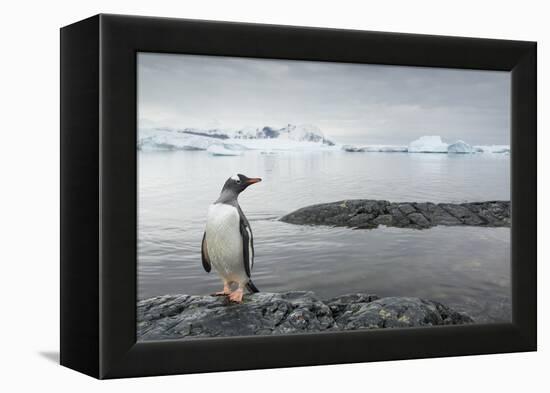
<box><xmin>138</xmin><ymin>292</ymin><xmax>334</xmax><ymax>340</ymax></box>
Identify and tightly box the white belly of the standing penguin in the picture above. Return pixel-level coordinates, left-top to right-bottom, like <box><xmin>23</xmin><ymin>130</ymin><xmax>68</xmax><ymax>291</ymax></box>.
<box><xmin>206</xmin><ymin>203</ymin><xmax>248</xmax><ymax>284</ymax></box>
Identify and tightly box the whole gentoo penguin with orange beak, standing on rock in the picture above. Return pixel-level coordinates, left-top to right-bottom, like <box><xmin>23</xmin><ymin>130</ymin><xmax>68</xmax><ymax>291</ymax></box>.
<box><xmin>201</xmin><ymin>174</ymin><xmax>262</xmax><ymax>303</ymax></box>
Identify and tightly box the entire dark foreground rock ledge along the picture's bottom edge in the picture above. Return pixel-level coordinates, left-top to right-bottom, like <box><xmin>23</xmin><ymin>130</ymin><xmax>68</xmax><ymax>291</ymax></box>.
<box><xmin>137</xmin><ymin>292</ymin><xmax>473</xmax><ymax>340</ymax></box>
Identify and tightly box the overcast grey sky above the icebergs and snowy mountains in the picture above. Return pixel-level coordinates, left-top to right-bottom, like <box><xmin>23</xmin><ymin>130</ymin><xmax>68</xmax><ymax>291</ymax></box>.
<box><xmin>138</xmin><ymin>53</ymin><xmax>510</xmax><ymax>144</ymax></box>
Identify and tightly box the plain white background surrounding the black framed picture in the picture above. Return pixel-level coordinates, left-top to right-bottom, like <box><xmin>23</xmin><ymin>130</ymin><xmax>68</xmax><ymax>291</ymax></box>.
<box><xmin>0</xmin><ymin>0</ymin><xmax>550</xmax><ymax>393</ymax></box>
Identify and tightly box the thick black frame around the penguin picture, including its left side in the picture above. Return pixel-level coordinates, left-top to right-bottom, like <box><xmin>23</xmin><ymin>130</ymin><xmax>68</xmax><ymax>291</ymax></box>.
<box><xmin>61</xmin><ymin>14</ymin><xmax>537</xmax><ymax>379</ymax></box>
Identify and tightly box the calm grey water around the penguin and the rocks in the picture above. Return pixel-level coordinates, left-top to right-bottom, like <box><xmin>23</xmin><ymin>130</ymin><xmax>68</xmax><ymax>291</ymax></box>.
<box><xmin>138</xmin><ymin>151</ymin><xmax>511</xmax><ymax>322</ymax></box>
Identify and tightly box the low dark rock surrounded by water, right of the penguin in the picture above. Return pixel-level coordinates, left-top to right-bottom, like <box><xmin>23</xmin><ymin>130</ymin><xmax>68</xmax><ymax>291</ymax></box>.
<box><xmin>281</xmin><ymin>199</ymin><xmax>510</xmax><ymax>229</ymax></box>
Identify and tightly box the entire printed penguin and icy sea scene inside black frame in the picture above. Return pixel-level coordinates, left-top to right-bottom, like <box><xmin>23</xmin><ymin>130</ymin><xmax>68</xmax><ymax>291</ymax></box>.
<box><xmin>136</xmin><ymin>53</ymin><xmax>512</xmax><ymax>341</ymax></box>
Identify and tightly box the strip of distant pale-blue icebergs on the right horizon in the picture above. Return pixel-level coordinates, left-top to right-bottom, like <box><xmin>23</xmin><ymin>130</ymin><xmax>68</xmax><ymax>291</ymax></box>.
<box><xmin>342</xmin><ymin>135</ymin><xmax>510</xmax><ymax>154</ymax></box>
